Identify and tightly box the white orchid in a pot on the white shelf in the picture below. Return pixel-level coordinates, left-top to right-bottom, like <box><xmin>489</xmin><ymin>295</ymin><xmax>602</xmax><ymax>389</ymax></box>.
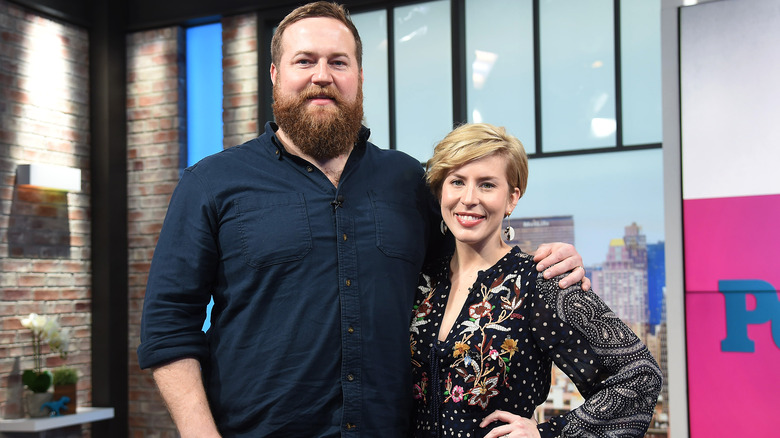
<box><xmin>21</xmin><ymin>313</ymin><xmax>68</xmax><ymax>417</ymax></box>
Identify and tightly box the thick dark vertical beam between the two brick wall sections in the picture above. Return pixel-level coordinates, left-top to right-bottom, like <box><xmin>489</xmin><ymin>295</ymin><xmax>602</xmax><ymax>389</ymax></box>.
<box><xmin>89</xmin><ymin>0</ymin><xmax>129</xmax><ymax>438</ymax></box>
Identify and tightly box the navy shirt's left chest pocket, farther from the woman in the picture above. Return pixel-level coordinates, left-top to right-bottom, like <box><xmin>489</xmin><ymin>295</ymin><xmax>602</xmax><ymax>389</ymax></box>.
<box><xmin>235</xmin><ymin>193</ymin><xmax>312</xmax><ymax>269</ymax></box>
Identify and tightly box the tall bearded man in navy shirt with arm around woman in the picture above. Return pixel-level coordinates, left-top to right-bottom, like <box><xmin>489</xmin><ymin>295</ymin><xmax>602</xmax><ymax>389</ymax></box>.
<box><xmin>138</xmin><ymin>2</ymin><xmax>583</xmax><ymax>437</ymax></box>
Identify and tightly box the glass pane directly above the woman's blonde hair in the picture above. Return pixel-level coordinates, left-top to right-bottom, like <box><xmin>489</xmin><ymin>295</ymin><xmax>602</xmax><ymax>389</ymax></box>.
<box><xmin>466</xmin><ymin>0</ymin><xmax>536</xmax><ymax>153</ymax></box>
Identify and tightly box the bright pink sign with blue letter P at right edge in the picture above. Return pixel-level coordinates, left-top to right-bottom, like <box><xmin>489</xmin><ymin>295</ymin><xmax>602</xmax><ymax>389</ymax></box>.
<box><xmin>683</xmin><ymin>195</ymin><xmax>780</xmax><ymax>438</ymax></box>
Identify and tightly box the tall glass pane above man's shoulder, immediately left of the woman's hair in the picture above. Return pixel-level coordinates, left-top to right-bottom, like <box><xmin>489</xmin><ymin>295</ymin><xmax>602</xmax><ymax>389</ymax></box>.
<box><xmin>393</xmin><ymin>0</ymin><xmax>452</xmax><ymax>161</ymax></box>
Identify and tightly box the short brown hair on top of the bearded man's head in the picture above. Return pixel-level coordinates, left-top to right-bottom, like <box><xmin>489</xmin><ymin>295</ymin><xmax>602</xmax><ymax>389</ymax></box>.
<box><xmin>271</xmin><ymin>1</ymin><xmax>363</xmax><ymax>69</ymax></box>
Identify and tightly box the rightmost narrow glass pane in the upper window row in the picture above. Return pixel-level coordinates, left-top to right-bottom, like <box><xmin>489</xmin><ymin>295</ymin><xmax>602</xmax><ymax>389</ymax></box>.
<box><xmin>620</xmin><ymin>0</ymin><xmax>663</xmax><ymax>146</ymax></box>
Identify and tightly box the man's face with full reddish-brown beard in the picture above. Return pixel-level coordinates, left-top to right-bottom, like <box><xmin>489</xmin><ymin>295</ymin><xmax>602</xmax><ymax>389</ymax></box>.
<box><xmin>271</xmin><ymin>18</ymin><xmax>363</xmax><ymax>159</ymax></box>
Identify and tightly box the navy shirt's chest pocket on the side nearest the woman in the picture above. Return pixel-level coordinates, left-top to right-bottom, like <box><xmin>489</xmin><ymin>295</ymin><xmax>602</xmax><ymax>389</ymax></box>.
<box><xmin>369</xmin><ymin>191</ymin><xmax>425</xmax><ymax>264</ymax></box>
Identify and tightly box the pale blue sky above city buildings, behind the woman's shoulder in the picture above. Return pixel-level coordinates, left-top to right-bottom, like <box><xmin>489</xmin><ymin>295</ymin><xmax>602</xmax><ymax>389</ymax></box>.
<box><xmin>510</xmin><ymin>150</ymin><xmax>664</xmax><ymax>266</ymax></box>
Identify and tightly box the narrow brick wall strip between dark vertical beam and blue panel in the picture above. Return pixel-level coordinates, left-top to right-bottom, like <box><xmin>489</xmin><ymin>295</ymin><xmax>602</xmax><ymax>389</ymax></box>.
<box><xmin>127</xmin><ymin>28</ymin><xmax>185</xmax><ymax>437</ymax></box>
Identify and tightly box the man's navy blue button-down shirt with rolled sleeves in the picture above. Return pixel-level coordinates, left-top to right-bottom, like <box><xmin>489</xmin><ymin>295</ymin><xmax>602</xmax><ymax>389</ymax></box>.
<box><xmin>138</xmin><ymin>123</ymin><xmax>440</xmax><ymax>437</ymax></box>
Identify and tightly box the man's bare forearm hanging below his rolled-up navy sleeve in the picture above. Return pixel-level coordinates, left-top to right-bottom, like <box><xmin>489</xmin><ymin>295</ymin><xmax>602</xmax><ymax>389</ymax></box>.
<box><xmin>152</xmin><ymin>358</ymin><xmax>220</xmax><ymax>438</ymax></box>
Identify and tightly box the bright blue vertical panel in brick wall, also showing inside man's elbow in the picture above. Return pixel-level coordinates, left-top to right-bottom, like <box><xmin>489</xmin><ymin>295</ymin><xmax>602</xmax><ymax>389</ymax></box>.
<box><xmin>187</xmin><ymin>23</ymin><xmax>222</xmax><ymax>332</ymax></box>
